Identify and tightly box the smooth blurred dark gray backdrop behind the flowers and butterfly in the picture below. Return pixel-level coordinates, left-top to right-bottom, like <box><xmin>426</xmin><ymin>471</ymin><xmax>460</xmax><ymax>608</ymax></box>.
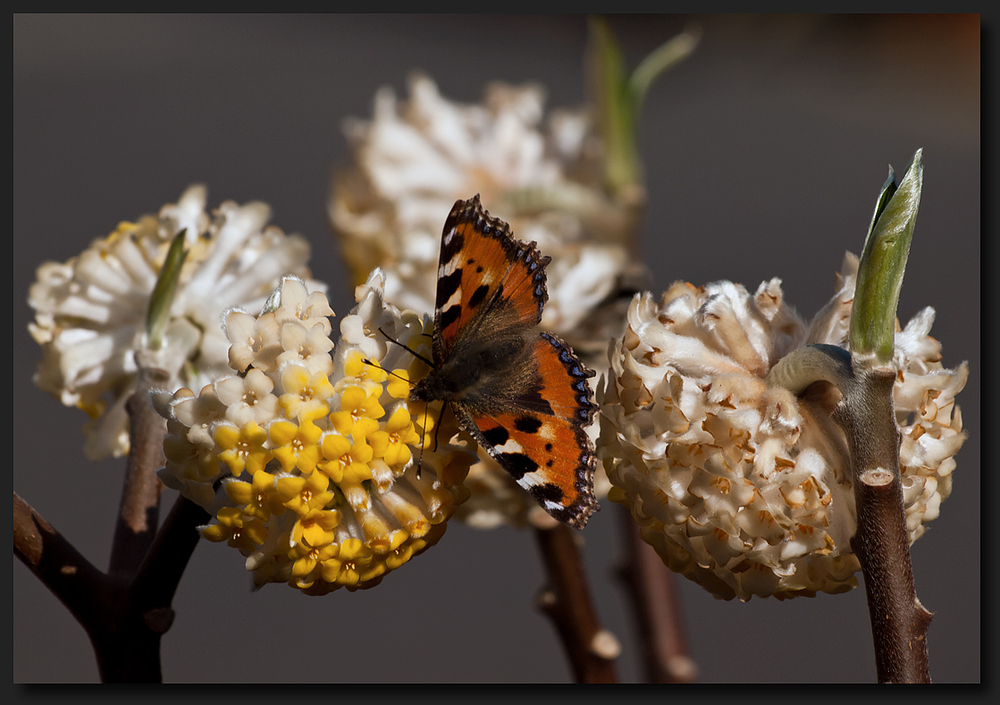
<box><xmin>12</xmin><ymin>15</ymin><xmax>982</xmax><ymax>683</ymax></box>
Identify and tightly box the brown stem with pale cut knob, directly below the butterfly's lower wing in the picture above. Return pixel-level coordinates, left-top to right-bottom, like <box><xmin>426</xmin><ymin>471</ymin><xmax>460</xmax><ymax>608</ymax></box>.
<box><xmin>534</xmin><ymin>524</ymin><xmax>621</xmax><ymax>683</ymax></box>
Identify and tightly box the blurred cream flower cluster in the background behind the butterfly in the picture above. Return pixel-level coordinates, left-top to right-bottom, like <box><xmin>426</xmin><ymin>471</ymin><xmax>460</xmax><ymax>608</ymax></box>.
<box><xmin>329</xmin><ymin>75</ymin><xmax>633</xmax><ymax>528</ymax></box>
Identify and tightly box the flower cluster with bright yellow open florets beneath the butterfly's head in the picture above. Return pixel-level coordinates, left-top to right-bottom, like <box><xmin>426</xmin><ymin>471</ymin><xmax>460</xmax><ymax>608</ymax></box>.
<box><xmin>154</xmin><ymin>270</ymin><xmax>475</xmax><ymax>595</ymax></box>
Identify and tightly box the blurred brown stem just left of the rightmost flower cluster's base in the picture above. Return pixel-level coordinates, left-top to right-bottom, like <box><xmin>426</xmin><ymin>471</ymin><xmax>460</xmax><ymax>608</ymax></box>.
<box><xmin>616</xmin><ymin>506</ymin><xmax>697</xmax><ymax>683</ymax></box>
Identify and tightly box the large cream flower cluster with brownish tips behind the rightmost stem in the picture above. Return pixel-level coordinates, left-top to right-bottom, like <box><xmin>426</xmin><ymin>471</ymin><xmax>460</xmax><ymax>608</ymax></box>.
<box><xmin>598</xmin><ymin>254</ymin><xmax>968</xmax><ymax>600</ymax></box>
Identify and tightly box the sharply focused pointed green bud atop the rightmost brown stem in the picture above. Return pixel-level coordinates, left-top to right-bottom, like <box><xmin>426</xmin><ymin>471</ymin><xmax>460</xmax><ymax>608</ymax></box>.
<box><xmin>850</xmin><ymin>149</ymin><xmax>924</xmax><ymax>364</ymax></box>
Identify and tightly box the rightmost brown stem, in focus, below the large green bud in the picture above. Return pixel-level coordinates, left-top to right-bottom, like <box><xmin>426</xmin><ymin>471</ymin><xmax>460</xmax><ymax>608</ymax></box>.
<box><xmin>833</xmin><ymin>368</ymin><xmax>931</xmax><ymax>683</ymax></box>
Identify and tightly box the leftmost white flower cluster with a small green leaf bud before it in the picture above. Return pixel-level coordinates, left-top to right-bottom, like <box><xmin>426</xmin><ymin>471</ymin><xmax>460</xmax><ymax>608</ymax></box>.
<box><xmin>28</xmin><ymin>185</ymin><xmax>324</xmax><ymax>459</ymax></box>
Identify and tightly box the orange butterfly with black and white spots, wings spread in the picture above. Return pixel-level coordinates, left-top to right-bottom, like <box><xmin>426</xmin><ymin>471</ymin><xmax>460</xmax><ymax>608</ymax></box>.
<box><xmin>410</xmin><ymin>195</ymin><xmax>600</xmax><ymax>529</ymax></box>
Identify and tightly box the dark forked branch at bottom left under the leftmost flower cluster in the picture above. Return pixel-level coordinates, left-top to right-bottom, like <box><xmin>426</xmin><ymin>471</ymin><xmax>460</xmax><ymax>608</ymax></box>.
<box><xmin>14</xmin><ymin>360</ymin><xmax>209</xmax><ymax>683</ymax></box>
